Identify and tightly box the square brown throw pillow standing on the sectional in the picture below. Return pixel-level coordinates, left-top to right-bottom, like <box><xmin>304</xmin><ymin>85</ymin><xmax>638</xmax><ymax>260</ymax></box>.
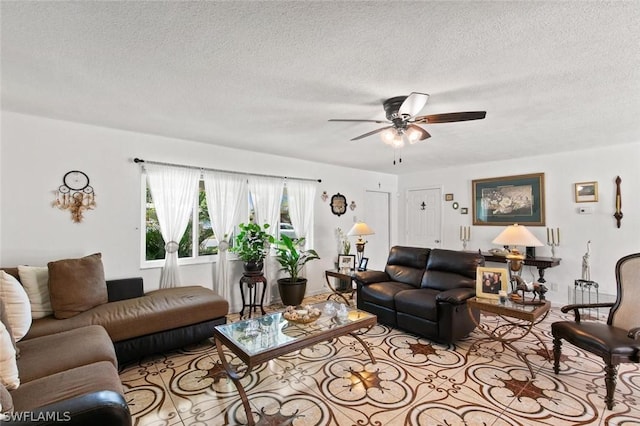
<box><xmin>48</xmin><ymin>253</ymin><xmax>108</xmax><ymax>319</ymax></box>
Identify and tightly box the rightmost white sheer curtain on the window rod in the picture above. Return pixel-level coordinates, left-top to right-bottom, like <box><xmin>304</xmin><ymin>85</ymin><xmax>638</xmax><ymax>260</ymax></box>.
<box><xmin>287</xmin><ymin>180</ymin><xmax>316</xmax><ymax>249</ymax></box>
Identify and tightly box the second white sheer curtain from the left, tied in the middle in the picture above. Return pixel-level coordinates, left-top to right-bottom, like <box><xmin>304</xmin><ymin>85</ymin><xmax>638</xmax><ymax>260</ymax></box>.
<box><xmin>203</xmin><ymin>171</ymin><xmax>247</xmax><ymax>306</ymax></box>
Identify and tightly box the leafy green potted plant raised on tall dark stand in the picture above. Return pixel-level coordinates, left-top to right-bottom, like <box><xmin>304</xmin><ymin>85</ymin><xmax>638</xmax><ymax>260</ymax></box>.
<box><xmin>229</xmin><ymin>222</ymin><xmax>274</xmax><ymax>272</ymax></box>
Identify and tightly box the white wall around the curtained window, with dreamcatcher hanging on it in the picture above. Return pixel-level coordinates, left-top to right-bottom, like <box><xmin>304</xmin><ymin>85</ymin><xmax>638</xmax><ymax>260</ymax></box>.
<box><xmin>0</xmin><ymin>112</ymin><xmax>397</xmax><ymax>309</ymax></box>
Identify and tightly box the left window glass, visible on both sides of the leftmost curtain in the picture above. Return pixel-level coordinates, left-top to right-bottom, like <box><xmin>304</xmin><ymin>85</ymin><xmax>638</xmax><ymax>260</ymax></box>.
<box><xmin>145</xmin><ymin>179</ymin><xmax>218</xmax><ymax>261</ymax></box>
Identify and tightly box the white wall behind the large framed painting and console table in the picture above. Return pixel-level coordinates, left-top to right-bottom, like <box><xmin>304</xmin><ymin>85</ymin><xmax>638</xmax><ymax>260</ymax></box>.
<box><xmin>398</xmin><ymin>143</ymin><xmax>640</xmax><ymax>304</ymax></box>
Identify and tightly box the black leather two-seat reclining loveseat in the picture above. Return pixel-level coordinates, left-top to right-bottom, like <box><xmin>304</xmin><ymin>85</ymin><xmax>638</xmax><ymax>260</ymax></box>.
<box><xmin>355</xmin><ymin>246</ymin><xmax>484</xmax><ymax>343</ymax></box>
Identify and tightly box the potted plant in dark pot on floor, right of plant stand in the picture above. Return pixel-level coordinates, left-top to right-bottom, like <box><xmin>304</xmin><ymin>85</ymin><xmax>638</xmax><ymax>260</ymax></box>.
<box><xmin>276</xmin><ymin>234</ymin><xmax>320</xmax><ymax>306</ymax></box>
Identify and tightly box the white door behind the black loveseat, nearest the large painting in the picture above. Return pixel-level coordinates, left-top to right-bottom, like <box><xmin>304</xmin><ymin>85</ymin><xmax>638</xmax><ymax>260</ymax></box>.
<box><xmin>405</xmin><ymin>188</ymin><xmax>442</xmax><ymax>248</ymax></box>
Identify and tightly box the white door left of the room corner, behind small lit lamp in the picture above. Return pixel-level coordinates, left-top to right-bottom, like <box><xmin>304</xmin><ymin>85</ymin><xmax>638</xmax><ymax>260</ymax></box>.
<box><xmin>364</xmin><ymin>191</ymin><xmax>391</xmax><ymax>270</ymax></box>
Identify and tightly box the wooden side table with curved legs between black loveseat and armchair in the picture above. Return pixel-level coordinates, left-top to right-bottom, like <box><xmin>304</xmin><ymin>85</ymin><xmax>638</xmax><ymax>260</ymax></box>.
<box><xmin>467</xmin><ymin>297</ymin><xmax>552</xmax><ymax>379</ymax></box>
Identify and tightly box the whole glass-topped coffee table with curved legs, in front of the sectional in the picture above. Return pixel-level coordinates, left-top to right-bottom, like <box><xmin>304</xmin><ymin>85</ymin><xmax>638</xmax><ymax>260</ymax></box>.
<box><xmin>213</xmin><ymin>302</ymin><xmax>377</xmax><ymax>425</ymax></box>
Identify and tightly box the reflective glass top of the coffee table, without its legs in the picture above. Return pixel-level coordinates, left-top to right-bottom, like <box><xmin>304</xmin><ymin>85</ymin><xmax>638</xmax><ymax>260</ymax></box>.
<box><xmin>216</xmin><ymin>302</ymin><xmax>375</xmax><ymax>356</ymax></box>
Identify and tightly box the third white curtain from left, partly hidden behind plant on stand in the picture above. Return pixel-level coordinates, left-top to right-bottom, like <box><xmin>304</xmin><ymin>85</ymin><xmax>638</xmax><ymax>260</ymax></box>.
<box><xmin>249</xmin><ymin>176</ymin><xmax>284</xmax><ymax>301</ymax></box>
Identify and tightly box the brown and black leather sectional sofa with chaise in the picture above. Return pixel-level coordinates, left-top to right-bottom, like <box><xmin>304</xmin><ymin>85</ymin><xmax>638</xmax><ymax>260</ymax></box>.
<box><xmin>0</xmin><ymin>268</ymin><xmax>229</xmax><ymax>426</ymax></box>
